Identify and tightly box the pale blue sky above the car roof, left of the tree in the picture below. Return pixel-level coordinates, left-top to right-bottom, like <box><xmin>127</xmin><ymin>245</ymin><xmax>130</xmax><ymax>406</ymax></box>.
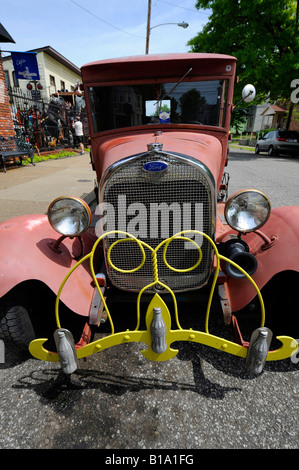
<box><xmin>0</xmin><ymin>0</ymin><xmax>210</xmax><ymax>67</ymax></box>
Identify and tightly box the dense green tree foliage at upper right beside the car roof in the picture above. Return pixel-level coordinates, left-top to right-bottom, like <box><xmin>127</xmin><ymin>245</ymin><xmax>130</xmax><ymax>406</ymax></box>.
<box><xmin>188</xmin><ymin>0</ymin><xmax>299</xmax><ymax>101</ymax></box>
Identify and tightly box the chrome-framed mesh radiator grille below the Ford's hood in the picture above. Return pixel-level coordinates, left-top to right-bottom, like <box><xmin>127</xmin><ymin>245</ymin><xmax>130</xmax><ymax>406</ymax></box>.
<box><xmin>101</xmin><ymin>152</ymin><xmax>215</xmax><ymax>291</ymax></box>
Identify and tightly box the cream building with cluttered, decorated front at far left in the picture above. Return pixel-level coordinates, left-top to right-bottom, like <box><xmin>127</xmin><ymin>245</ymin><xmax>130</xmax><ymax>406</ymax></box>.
<box><xmin>0</xmin><ymin>46</ymin><xmax>89</xmax><ymax>150</ymax></box>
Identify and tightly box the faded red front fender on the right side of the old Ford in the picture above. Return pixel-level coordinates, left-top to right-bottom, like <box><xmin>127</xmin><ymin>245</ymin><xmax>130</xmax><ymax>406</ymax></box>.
<box><xmin>227</xmin><ymin>206</ymin><xmax>299</xmax><ymax>312</ymax></box>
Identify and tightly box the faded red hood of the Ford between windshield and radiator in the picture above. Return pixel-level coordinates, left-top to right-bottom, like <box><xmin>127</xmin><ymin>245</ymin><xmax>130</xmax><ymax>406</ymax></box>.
<box><xmin>93</xmin><ymin>130</ymin><xmax>226</xmax><ymax>189</ymax></box>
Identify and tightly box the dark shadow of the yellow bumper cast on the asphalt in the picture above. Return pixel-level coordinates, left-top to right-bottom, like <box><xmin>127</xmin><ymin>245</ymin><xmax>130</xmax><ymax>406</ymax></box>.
<box><xmin>8</xmin><ymin>344</ymin><xmax>294</xmax><ymax>413</ymax></box>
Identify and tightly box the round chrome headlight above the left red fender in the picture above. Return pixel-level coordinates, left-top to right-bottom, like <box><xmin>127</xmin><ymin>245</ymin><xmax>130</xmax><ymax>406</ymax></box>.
<box><xmin>47</xmin><ymin>197</ymin><xmax>91</xmax><ymax>237</ymax></box>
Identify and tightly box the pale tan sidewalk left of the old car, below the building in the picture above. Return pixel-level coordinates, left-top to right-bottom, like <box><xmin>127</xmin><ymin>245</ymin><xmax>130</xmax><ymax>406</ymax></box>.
<box><xmin>0</xmin><ymin>152</ymin><xmax>96</xmax><ymax>222</ymax></box>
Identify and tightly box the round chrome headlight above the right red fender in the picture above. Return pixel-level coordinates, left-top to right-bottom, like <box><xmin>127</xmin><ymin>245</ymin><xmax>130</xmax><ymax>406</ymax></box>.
<box><xmin>224</xmin><ymin>189</ymin><xmax>271</xmax><ymax>233</ymax></box>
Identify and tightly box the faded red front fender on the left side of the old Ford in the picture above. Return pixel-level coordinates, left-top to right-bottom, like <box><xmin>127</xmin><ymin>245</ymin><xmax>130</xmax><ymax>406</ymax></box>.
<box><xmin>0</xmin><ymin>215</ymin><xmax>95</xmax><ymax>315</ymax></box>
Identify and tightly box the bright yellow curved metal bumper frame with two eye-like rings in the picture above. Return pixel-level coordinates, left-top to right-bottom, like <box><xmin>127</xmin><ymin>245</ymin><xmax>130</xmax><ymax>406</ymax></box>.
<box><xmin>29</xmin><ymin>230</ymin><xmax>298</xmax><ymax>362</ymax></box>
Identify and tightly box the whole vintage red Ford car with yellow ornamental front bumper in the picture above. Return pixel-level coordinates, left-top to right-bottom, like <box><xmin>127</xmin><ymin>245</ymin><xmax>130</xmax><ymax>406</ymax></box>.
<box><xmin>0</xmin><ymin>53</ymin><xmax>299</xmax><ymax>374</ymax></box>
